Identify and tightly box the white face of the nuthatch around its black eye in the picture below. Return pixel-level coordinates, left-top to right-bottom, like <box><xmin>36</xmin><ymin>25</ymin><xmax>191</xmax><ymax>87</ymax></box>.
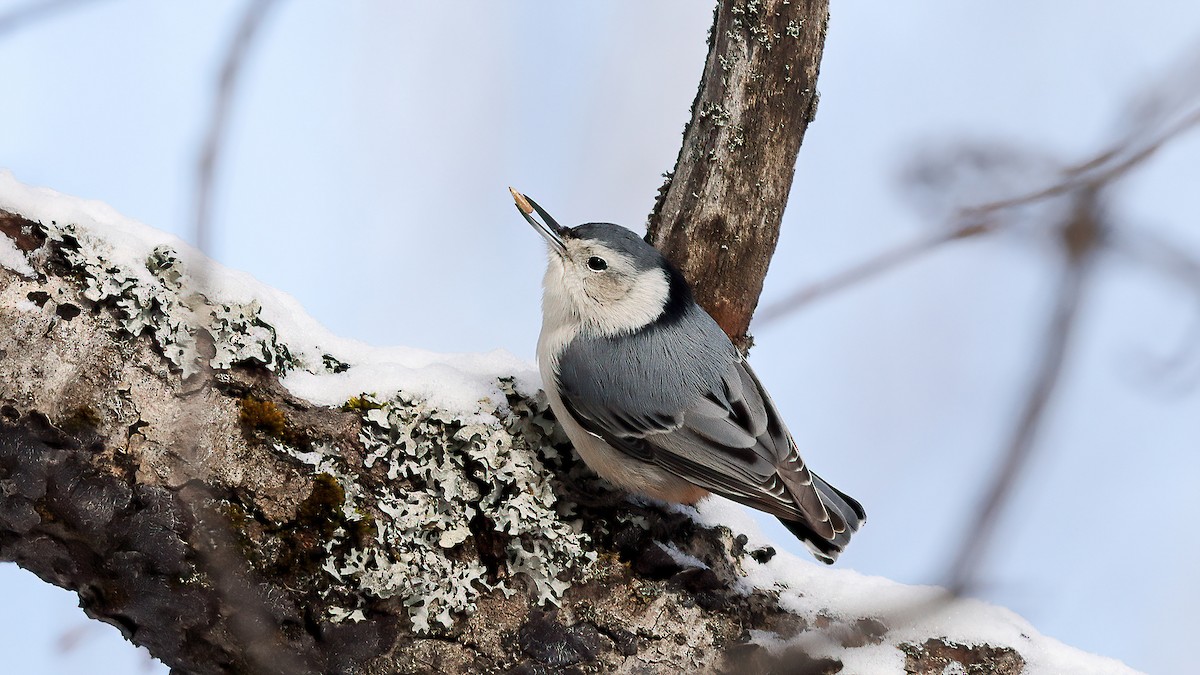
<box><xmin>542</xmin><ymin>239</ymin><xmax>671</xmax><ymax>336</ymax></box>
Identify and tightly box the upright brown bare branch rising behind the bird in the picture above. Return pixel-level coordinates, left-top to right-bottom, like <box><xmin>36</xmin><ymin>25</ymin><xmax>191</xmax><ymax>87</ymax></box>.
<box><xmin>647</xmin><ymin>0</ymin><xmax>829</xmax><ymax>351</ymax></box>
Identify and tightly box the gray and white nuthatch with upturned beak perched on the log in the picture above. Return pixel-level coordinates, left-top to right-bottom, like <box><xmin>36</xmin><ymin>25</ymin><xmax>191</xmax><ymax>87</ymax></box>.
<box><xmin>509</xmin><ymin>187</ymin><xmax>866</xmax><ymax>563</ymax></box>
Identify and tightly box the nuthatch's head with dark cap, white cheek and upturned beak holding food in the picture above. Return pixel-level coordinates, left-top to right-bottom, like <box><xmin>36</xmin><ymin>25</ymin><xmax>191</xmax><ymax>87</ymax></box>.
<box><xmin>510</xmin><ymin>189</ymin><xmax>692</xmax><ymax>336</ymax></box>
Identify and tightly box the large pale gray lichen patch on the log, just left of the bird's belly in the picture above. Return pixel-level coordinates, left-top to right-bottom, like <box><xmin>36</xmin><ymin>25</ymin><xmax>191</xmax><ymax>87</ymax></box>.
<box><xmin>306</xmin><ymin>382</ymin><xmax>595</xmax><ymax>633</ymax></box>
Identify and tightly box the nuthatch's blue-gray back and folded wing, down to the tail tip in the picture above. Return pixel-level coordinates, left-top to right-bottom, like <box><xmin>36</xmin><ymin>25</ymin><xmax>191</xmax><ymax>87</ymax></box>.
<box><xmin>558</xmin><ymin>315</ymin><xmax>865</xmax><ymax>555</ymax></box>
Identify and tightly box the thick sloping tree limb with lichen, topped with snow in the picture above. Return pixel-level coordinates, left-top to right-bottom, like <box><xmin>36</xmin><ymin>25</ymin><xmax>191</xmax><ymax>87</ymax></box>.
<box><xmin>0</xmin><ymin>174</ymin><xmax>1129</xmax><ymax>674</ymax></box>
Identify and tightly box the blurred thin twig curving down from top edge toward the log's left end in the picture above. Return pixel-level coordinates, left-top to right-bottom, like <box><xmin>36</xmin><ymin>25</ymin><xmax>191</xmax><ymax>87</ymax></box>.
<box><xmin>193</xmin><ymin>0</ymin><xmax>276</xmax><ymax>252</ymax></box>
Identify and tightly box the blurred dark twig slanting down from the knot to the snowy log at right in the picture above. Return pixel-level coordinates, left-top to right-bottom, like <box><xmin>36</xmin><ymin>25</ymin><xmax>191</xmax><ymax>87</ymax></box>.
<box><xmin>947</xmin><ymin>191</ymin><xmax>1103</xmax><ymax>595</ymax></box>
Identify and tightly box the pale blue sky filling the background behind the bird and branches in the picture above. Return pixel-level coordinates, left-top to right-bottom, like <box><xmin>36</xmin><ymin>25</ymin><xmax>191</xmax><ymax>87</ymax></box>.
<box><xmin>0</xmin><ymin>0</ymin><xmax>1200</xmax><ymax>673</ymax></box>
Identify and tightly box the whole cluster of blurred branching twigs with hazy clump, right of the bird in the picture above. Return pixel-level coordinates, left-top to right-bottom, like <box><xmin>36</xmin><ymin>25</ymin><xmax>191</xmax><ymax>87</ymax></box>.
<box><xmin>760</xmin><ymin>39</ymin><xmax>1200</xmax><ymax>593</ymax></box>
